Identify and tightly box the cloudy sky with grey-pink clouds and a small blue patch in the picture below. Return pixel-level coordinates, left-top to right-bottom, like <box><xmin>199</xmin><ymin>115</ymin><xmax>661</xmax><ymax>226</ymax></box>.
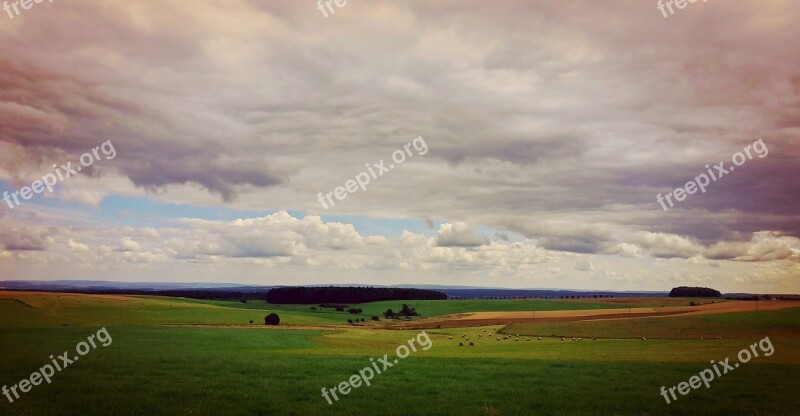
<box><xmin>0</xmin><ymin>0</ymin><xmax>800</xmax><ymax>293</ymax></box>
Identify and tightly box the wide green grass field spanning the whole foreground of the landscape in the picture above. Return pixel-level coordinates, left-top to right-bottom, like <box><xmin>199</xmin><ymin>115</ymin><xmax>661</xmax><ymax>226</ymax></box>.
<box><xmin>0</xmin><ymin>294</ymin><xmax>800</xmax><ymax>416</ymax></box>
